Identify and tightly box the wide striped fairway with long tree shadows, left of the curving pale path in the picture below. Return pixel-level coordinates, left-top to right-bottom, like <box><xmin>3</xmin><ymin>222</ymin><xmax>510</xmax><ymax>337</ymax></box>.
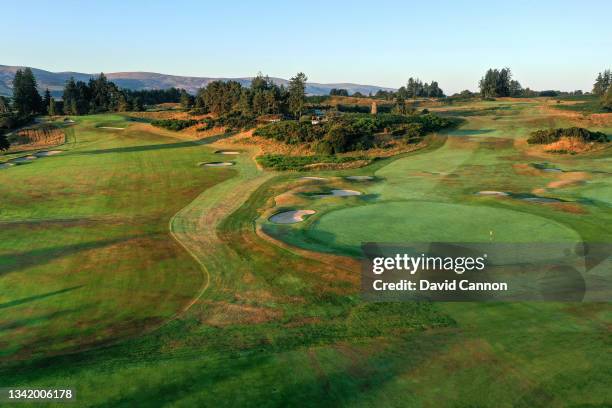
<box><xmin>0</xmin><ymin>115</ymin><xmax>232</xmax><ymax>358</ymax></box>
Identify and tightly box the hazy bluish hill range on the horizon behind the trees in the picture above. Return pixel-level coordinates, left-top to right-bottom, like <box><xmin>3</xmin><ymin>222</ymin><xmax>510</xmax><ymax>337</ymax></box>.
<box><xmin>0</xmin><ymin>65</ymin><xmax>392</xmax><ymax>97</ymax></box>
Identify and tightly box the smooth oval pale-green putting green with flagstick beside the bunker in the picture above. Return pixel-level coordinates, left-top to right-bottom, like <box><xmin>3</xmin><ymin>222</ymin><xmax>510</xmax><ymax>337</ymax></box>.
<box><xmin>306</xmin><ymin>201</ymin><xmax>580</xmax><ymax>250</ymax></box>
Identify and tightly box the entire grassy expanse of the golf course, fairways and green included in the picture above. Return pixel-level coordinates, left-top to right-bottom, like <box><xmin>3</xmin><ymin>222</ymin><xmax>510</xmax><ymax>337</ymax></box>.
<box><xmin>0</xmin><ymin>99</ymin><xmax>612</xmax><ymax>407</ymax></box>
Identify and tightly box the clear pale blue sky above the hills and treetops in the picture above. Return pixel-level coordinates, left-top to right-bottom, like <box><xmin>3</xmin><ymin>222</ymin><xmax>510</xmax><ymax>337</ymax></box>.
<box><xmin>0</xmin><ymin>0</ymin><xmax>612</xmax><ymax>94</ymax></box>
